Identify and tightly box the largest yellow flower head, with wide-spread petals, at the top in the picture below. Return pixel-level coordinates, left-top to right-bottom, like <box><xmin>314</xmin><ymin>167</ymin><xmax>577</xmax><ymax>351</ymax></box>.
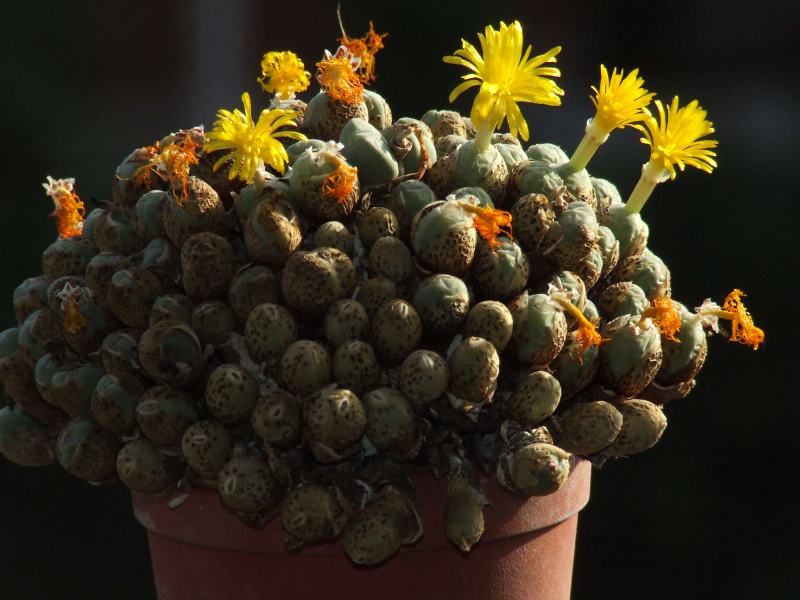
<box><xmin>444</xmin><ymin>21</ymin><xmax>564</xmax><ymax>140</ymax></box>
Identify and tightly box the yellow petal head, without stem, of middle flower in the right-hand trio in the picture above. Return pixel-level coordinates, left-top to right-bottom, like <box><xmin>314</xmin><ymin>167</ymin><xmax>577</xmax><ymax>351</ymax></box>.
<box><xmin>590</xmin><ymin>65</ymin><xmax>655</xmax><ymax>132</ymax></box>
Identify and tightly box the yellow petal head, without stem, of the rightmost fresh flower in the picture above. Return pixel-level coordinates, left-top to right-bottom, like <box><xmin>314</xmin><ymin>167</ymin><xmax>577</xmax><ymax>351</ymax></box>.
<box><xmin>634</xmin><ymin>96</ymin><xmax>717</xmax><ymax>179</ymax></box>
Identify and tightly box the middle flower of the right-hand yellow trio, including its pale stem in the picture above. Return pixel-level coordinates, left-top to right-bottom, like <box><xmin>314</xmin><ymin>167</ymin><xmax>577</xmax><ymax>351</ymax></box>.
<box><xmin>569</xmin><ymin>65</ymin><xmax>655</xmax><ymax>173</ymax></box>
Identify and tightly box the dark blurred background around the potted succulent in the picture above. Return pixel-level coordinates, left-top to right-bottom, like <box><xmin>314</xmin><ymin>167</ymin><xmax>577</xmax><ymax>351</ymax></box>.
<box><xmin>0</xmin><ymin>0</ymin><xmax>800</xmax><ymax>600</ymax></box>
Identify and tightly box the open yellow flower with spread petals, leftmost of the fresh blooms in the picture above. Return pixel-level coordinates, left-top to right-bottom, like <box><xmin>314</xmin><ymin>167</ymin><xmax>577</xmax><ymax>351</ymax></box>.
<box><xmin>203</xmin><ymin>92</ymin><xmax>306</xmax><ymax>183</ymax></box>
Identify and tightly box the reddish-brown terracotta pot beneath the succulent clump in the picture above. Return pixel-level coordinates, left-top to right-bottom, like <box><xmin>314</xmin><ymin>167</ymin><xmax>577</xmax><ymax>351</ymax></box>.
<box><xmin>133</xmin><ymin>461</ymin><xmax>591</xmax><ymax>600</ymax></box>
